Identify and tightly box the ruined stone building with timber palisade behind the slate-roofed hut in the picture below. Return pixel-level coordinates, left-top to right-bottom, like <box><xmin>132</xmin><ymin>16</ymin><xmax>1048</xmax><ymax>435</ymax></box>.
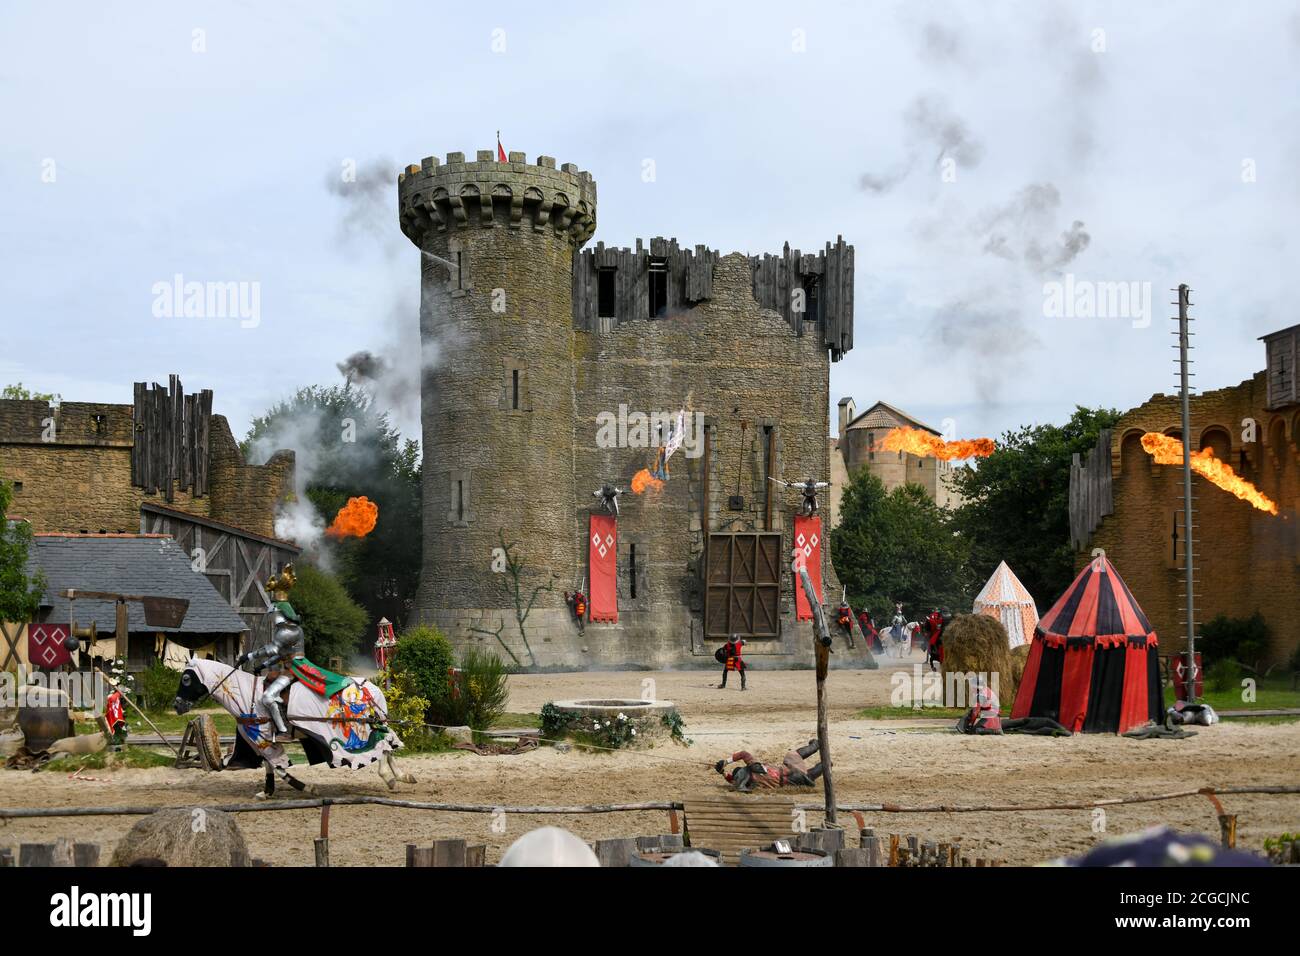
<box><xmin>0</xmin><ymin>376</ymin><xmax>299</xmax><ymax>663</ymax></box>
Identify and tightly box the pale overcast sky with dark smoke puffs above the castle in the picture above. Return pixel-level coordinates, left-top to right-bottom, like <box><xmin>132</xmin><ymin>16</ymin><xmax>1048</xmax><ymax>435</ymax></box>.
<box><xmin>0</xmin><ymin>0</ymin><xmax>1300</xmax><ymax>450</ymax></box>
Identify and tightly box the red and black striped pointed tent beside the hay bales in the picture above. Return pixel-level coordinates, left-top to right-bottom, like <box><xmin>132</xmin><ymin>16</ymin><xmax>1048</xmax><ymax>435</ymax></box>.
<box><xmin>1011</xmin><ymin>551</ymin><xmax>1164</xmax><ymax>734</ymax></box>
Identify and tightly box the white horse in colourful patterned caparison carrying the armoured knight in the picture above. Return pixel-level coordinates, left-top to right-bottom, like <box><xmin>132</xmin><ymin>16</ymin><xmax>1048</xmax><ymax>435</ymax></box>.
<box><xmin>174</xmin><ymin>658</ymin><xmax>415</xmax><ymax>797</ymax></box>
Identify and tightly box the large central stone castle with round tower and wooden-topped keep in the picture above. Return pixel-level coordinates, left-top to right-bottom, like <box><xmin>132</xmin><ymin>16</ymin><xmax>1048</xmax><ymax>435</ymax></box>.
<box><xmin>398</xmin><ymin>151</ymin><xmax>853</xmax><ymax>667</ymax></box>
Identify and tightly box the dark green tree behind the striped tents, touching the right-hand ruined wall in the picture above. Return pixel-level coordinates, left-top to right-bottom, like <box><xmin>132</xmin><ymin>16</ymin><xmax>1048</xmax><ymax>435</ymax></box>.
<box><xmin>954</xmin><ymin>406</ymin><xmax>1119</xmax><ymax>611</ymax></box>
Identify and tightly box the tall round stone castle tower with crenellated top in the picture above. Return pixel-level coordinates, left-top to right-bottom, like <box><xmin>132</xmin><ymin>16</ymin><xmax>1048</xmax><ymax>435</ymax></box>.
<box><xmin>398</xmin><ymin>150</ymin><xmax>595</xmax><ymax>641</ymax></box>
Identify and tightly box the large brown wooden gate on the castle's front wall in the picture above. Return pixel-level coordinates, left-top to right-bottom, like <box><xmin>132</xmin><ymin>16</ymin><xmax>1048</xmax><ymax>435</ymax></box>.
<box><xmin>705</xmin><ymin>532</ymin><xmax>781</xmax><ymax>640</ymax></box>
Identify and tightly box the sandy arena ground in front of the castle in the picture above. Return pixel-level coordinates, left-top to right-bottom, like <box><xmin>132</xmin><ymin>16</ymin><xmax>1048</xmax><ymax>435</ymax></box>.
<box><xmin>0</xmin><ymin>658</ymin><xmax>1300</xmax><ymax>866</ymax></box>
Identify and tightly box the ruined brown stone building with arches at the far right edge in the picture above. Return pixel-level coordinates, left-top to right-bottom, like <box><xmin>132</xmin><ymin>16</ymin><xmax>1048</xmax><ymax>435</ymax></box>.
<box><xmin>1071</xmin><ymin>325</ymin><xmax>1300</xmax><ymax>661</ymax></box>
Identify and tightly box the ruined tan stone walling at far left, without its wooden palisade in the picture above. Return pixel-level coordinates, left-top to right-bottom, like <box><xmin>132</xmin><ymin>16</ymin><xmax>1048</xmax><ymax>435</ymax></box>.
<box><xmin>0</xmin><ymin>401</ymin><xmax>294</xmax><ymax>535</ymax></box>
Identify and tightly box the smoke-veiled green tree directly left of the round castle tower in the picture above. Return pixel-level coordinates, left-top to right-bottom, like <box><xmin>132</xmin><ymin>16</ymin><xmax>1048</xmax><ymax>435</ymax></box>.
<box><xmin>241</xmin><ymin>385</ymin><xmax>421</xmax><ymax>642</ymax></box>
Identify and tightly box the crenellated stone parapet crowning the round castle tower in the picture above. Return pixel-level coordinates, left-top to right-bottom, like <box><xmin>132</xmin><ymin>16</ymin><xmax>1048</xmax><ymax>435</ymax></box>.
<box><xmin>398</xmin><ymin>150</ymin><xmax>595</xmax><ymax>247</ymax></box>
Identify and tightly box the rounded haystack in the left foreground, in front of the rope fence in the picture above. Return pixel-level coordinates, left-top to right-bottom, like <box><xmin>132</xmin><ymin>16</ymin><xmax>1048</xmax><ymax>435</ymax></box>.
<box><xmin>111</xmin><ymin>809</ymin><xmax>250</xmax><ymax>866</ymax></box>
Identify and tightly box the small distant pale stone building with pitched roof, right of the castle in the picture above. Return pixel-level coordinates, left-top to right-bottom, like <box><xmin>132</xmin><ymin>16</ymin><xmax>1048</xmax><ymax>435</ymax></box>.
<box><xmin>831</xmin><ymin>397</ymin><xmax>961</xmax><ymax>520</ymax></box>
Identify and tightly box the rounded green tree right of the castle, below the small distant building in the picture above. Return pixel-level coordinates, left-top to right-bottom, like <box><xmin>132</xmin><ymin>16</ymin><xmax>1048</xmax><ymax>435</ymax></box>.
<box><xmin>831</xmin><ymin>468</ymin><xmax>972</xmax><ymax>622</ymax></box>
